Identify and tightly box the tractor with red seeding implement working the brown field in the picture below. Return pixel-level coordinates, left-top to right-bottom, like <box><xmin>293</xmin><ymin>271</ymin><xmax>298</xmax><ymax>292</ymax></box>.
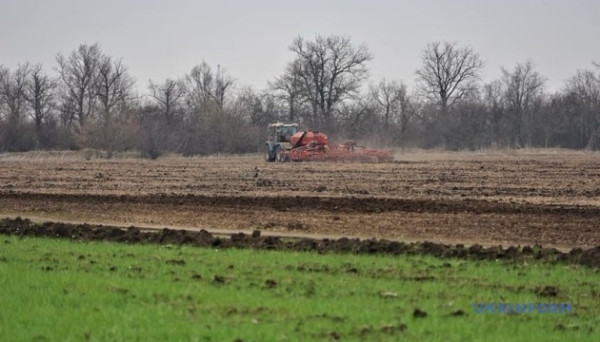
<box><xmin>265</xmin><ymin>123</ymin><xmax>394</xmax><ymax>163</ymax></box>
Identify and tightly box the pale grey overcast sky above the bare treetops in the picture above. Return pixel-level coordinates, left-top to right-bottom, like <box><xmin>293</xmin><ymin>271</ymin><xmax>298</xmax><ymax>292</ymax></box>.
<box><xmin>0</xmin><ymin>0</ymin><xmax>600</xmax><ymax>91</ymax></box>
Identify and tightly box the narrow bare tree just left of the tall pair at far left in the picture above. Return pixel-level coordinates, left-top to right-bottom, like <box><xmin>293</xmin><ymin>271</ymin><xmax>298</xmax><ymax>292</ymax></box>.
<box><xmin>25</xmin><ymin>64</ymin><xmax>56</xmax><ymax>145</ymax></box>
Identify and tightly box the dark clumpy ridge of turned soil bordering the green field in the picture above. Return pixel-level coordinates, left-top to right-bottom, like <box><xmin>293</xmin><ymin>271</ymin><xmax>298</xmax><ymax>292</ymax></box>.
<box><xmin>0</xmin><ymin>217</ymin><xmax>600</xmax><ymax>268</ymax></box>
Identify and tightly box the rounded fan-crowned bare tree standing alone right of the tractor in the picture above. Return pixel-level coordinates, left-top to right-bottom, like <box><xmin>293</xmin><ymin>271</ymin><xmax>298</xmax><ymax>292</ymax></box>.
<box><xmin>416</xmin><ymin>42</ymin><xmax>484</xmax><ymax>116</ymax></box>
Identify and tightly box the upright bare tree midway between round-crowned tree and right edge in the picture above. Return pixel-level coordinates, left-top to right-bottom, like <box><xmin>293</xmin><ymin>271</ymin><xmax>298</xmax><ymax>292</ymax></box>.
<box><xmin>502</xmin><ymin>61</ymin><xmax>546</xmax><ymax>146</ymax></box>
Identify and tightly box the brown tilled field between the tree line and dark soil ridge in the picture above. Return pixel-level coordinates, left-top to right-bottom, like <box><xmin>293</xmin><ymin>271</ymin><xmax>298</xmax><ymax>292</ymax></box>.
<box><xmin>0</xmin><ymin>152</ymin><xmax>600</xmax><ymax>248</ymax></box>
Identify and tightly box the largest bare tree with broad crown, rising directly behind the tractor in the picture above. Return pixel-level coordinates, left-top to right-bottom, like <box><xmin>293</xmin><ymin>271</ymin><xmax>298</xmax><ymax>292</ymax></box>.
<box><xmin>287</xmin><ymin>36</ymin><xmax>373</xmax><ymax>130</ymax></box>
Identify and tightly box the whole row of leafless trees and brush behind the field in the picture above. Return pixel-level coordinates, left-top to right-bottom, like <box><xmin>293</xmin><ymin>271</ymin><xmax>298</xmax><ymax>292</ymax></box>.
<box><xmin>0</xmin><ymin>35</ymin><xmax>600</xmax><ymax>159</ymax></box>
